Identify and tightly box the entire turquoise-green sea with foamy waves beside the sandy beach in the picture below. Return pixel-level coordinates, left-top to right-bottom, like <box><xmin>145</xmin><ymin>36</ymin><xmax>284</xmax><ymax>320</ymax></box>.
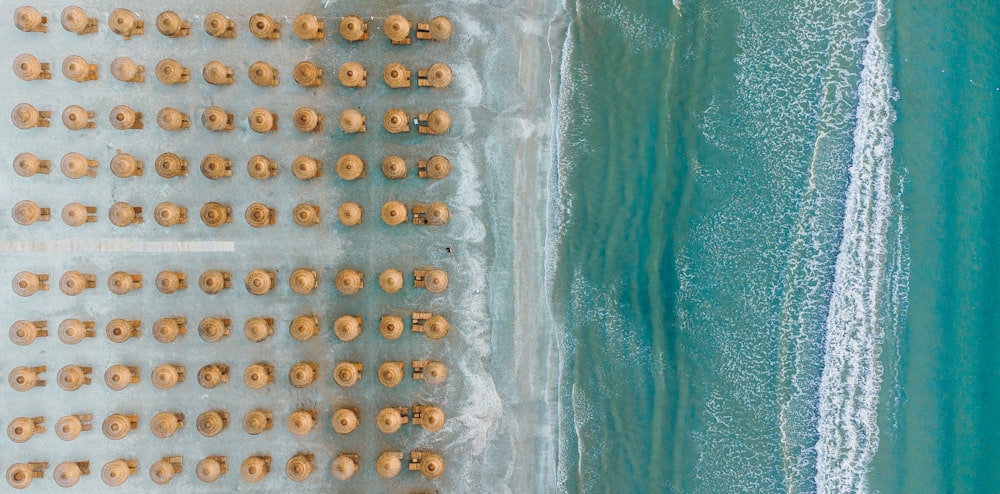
<box><xmin>550</xmin><ymin>0</ymin><xmax>1000</xmax><ymax>492</ymax></box>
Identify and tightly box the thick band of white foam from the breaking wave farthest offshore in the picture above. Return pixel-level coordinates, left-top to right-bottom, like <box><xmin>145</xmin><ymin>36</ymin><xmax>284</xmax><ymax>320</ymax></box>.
<box><xmin>816</xmin><ymin>0</ymin><xmax>895</xmax><ymax>493</ymax></box>
